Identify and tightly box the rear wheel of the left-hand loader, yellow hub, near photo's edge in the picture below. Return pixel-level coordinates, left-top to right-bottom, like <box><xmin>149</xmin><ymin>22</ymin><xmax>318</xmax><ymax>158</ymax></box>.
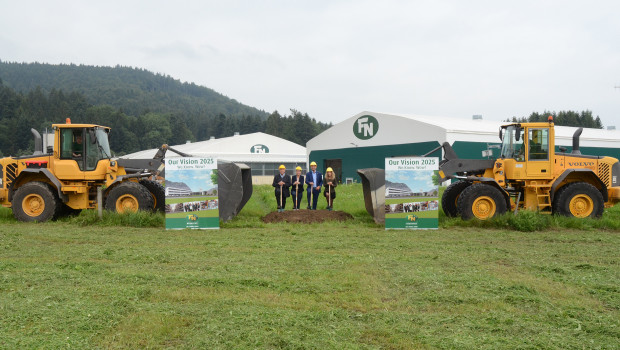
<box><xmin>12</xmin><ymin>181</ymin><xmax>62</xmax><ymax>222</ymax></box>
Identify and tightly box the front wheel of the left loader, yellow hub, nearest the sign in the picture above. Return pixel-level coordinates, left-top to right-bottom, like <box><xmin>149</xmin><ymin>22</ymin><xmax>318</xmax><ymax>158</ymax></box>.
<box><xmin>105</xmin><ymin>181</ymin><xmax>153</xmax><ymax>213</ymax></box>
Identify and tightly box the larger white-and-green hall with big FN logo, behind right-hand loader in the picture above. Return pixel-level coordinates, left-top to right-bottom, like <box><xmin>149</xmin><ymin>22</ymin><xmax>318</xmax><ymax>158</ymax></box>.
<box><xmin>306</xmin><ymin>111</ymin><xmax>620</xmax><ymax>182</ymax></box>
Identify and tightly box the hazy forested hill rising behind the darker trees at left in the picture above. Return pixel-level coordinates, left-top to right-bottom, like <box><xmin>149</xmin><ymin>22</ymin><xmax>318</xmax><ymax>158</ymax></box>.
<box><xmin>0</xmin><ymin>61</ymin><xmax>268</xmax><ymax>118</ymax></box>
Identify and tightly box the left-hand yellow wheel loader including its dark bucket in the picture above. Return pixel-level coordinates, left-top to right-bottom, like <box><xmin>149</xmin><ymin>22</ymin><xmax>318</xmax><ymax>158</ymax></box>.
<box><xmin>0</xmin><ymin>118</ymin><xmax>252</xmax><ymax>222</ymax></box>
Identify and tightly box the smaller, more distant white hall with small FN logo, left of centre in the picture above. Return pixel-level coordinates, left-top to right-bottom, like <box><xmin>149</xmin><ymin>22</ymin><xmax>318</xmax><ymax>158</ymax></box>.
<box><xmin>123</xmin><ymin>132</ymin><xmax>306</xmax><ymax>184</ymax></box>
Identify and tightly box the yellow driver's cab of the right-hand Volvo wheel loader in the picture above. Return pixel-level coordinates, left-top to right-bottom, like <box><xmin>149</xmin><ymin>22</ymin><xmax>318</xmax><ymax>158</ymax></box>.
<box><xmin>500</xmin><ymin>123</ymin><xmax>554</xmax><ymax>180</ymax></box>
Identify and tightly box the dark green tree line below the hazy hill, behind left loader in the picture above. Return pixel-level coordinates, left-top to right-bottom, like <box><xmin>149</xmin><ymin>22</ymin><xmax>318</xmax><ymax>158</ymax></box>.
<box><xmin>0</xmin><ymin>79</ymin><xmax>331</xmax><ymax>156</ymax></box>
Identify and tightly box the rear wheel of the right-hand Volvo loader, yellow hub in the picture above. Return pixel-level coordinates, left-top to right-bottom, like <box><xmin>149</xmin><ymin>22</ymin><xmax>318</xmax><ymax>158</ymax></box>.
<box><xmin>553</xmin><ymin>182</ymin><xmax>605</xmax><ymax>218</ymax></box>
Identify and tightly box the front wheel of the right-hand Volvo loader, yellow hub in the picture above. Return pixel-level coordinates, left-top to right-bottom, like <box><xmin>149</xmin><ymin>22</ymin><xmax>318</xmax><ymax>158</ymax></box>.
<box><xmin>457</xmin><ymin>183</ymin><xmax>507</xmax><ymax>220</ymax></box>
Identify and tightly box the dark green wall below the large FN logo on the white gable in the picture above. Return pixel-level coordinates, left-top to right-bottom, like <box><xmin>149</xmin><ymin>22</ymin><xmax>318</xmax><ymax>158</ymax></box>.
<box><xmin>309</xmin><ymin>141</ymin><xmax>442</xmax><ymax>182</ymax></box>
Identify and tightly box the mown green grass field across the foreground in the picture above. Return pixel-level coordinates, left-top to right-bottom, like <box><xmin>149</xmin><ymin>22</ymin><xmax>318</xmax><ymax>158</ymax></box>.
<box><xmin>0</xmin><ymin>185</ymin><xmax>620</xmax><ymax>349</ymax></box>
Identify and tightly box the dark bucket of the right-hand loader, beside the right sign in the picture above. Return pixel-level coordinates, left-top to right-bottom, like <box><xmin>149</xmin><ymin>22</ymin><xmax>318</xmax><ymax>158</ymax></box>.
<box><xmin>357</xmin><ymin>168</ymin><xmax>385</xmax><ymax>224</ymax></box>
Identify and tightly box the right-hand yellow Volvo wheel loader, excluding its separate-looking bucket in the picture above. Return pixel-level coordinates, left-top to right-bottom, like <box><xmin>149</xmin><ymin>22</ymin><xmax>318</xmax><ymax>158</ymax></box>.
<box><xmin>439</xmin><ymin>117</ymin><xmax>620</xmax><ymax>220</ymax></box>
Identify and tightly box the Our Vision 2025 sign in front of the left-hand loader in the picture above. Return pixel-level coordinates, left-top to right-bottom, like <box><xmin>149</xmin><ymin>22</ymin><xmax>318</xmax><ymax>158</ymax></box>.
<box><xmin>165</xmin><ymin>157</ymin><xmax>220</xmax><ymax>229</ymax></box>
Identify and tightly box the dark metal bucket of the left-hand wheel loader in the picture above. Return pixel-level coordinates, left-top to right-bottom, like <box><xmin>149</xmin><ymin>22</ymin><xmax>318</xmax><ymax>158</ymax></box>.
<box><xmin>217</xmin><ymin>160</ymin><xmax>252</xmax><ymax>222</ymax></box>
